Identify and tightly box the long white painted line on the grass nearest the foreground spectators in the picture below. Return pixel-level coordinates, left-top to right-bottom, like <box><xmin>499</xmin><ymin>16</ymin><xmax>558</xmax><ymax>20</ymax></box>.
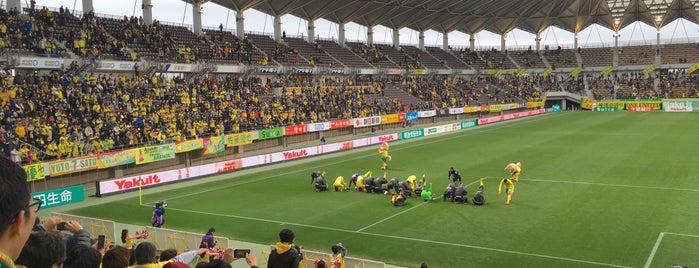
<box><xmin>168</xmin><ymin>203</ymin><xmax>632</xmax><ymax>268</ymax></box>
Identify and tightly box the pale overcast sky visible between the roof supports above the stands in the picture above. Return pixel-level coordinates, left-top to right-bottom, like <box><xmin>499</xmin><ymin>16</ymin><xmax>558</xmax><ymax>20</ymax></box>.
<box><xmin>30</xmin><ymin>0</ymin><xmax>699</xmax><ymax>48</ymax></box>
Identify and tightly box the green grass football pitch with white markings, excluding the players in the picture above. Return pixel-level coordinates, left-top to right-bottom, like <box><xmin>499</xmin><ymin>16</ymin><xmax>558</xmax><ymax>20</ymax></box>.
<box><xmin>67</xmin><ymin>112</ymin><xmax>699</xmax><ymax>267</ymax></box>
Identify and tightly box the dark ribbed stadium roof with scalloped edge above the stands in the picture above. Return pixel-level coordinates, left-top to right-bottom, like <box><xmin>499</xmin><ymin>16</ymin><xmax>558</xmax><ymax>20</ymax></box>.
<box><xmin>191</xmin><ymin>0</ymin><xmax>699</xmax><ymax>34</ymax></box>
